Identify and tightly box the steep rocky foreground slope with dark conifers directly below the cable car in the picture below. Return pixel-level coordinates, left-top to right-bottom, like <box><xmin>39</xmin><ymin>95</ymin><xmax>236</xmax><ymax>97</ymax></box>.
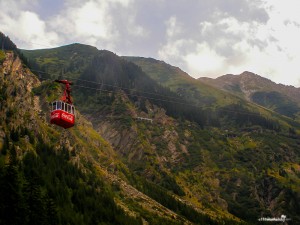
<box><xmin>0</xmin><ymin>51</ymin><xmax>220</xmax><ymax>224</ymax></box>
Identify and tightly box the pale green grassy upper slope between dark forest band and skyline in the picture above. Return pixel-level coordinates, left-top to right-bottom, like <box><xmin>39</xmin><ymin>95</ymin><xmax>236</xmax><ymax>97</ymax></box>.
<box><xmin>124</xmin><ymin>57</ymin><xmax>300</xmax><ymax>129</ymax></box>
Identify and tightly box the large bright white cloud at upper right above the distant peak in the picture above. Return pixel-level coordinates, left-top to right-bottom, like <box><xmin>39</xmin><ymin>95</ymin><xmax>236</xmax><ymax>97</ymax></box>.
<box><xmin>159</xmin><ymin>0</ymin><xmax>300</xmax><ymax>85</ymax></box>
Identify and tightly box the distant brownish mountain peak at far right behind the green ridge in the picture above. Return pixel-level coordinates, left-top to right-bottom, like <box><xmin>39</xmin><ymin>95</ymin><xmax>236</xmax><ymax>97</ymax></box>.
<box><xmin>199</xmin><ymin>72</ymin><xmax>300</xmax><ymax>121</ymax></box>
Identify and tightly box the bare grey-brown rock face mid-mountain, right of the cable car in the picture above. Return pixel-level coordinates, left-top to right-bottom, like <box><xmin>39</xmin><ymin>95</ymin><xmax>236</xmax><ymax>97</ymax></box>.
<box><xmin>86</xmin><ymin>95</ymin><xmax>188</xmax><ymax>167</ymax></box>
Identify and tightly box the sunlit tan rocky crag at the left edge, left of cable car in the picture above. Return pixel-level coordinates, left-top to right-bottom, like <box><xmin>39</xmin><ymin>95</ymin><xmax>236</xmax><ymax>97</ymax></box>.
<box><xmin>0</xmin><ymin>52</ymin><xmax>40</xmax><ymax>130</ymax></box>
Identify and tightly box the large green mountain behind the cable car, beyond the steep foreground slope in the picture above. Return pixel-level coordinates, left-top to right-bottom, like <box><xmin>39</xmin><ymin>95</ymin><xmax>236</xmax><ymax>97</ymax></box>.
<box><xmin>1</xmin><ymin>35</ymin><xmax>300</xmax><ymax>224</ymax></box>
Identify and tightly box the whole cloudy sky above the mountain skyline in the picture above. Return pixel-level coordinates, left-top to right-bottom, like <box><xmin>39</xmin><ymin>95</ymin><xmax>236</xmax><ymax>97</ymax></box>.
<box><xmin>0</xmin><ymin>0</ymin><xmax>300</xmax><ymax>87</ymax></box>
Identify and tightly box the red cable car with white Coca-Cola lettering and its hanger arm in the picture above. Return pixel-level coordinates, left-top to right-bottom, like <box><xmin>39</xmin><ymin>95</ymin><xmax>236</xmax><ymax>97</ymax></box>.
<box><xmin>50</xmin><ymin>80</ymin><xmax>75</xmax><ymax>129</ymax></box>
